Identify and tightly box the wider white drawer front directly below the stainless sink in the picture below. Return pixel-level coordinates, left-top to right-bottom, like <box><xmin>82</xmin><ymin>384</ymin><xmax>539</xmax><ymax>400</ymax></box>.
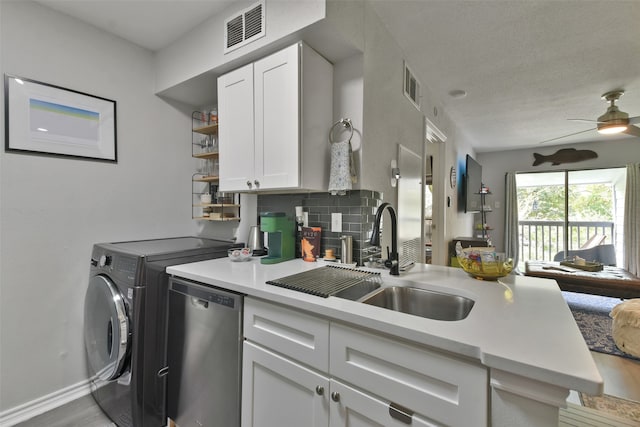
<box><xmin>330</xmin><ymin>323</ymin><xmax>488</xmax><ymax>426</ymax></box>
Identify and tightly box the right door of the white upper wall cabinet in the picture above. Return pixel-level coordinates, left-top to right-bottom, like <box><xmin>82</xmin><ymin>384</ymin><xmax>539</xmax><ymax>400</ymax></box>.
<box><xmin>252</xmin><ymin>44</ymin><xmax>300</xmax><ymax>189</ymax></box>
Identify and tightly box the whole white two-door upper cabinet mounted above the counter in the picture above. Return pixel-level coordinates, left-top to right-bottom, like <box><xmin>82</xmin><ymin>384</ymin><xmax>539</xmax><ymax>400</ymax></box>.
<box><xmin>218</xmin><ymin>43</ymin><xmax>333</xmax><ymax>191</ymax></box>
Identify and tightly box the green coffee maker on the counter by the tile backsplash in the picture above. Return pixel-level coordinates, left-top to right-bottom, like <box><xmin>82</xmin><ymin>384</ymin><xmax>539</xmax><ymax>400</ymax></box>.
<box><xmin>260</xmin><ymin>212</ymin><xmax>295</xmax><ymax>264</ymax></box>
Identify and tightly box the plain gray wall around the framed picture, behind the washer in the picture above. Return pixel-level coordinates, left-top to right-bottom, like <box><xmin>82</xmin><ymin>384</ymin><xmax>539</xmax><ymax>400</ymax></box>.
<box><xmin>0</xmin><ymin>1</ymin><xmax>196</xmax><ymax>419</ymax></box>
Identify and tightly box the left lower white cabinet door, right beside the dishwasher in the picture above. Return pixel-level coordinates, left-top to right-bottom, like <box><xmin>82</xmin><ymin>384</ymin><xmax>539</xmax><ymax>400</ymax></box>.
<box><xmin>242</xmin><ymin>341</ymin><xmax>329</xmax><ymax>427</ymax></box>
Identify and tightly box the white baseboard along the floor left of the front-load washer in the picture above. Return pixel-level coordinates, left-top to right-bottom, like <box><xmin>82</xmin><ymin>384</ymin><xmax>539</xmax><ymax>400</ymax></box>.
<box><xmin>0</xmin><ymin>380</ymin><xmax>91</xmax><ymax>427</ymax></box>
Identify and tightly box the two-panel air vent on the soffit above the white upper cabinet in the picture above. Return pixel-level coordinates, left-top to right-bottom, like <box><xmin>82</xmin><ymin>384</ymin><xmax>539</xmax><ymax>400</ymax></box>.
<box><xmin>224</xmin><ymin>0</ymin><xmax>265</xmax><ymax>53</ymax></box>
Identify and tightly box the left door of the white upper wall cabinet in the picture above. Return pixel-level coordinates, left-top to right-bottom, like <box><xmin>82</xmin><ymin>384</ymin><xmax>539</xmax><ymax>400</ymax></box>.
<box><xmin>218</xmin><ymin>64</ymin><xmax>254</xmax><ymax>191</ymax></box>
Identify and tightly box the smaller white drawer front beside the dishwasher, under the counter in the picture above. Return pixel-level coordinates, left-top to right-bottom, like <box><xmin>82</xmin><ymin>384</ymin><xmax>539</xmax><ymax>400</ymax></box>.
<box><xmin>244</xmin><ymin>298</ymin><xmax>329</xmax><ymax>372</ymax></box>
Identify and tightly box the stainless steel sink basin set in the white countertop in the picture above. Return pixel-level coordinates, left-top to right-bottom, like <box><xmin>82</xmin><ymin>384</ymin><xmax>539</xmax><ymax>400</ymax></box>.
<box><xmin>362</xmin><ymin>286</ymin><xmax>475</xmax><ymax>321</ymax></box>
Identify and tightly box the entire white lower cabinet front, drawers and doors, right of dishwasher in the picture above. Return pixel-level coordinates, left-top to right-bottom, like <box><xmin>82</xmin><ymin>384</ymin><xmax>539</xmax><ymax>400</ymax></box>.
<box><xmin>242</xmin><ymin>297</ymin><xmax>488</xmax><ymax>427</ymax></box>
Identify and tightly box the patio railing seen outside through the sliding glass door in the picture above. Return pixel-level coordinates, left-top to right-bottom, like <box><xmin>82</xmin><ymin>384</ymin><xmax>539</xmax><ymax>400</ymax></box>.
<box><xmin>518</xmin><ymin>220</ymin><xmax>614</xmax><ymax>262</ymax></box>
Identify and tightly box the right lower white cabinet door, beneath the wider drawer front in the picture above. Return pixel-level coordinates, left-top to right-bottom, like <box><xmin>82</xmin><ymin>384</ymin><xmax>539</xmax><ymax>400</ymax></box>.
<box><xmin>330</xmin><ymin>380</ymin><xmax>441</xmax><ymax>427</ymax></box>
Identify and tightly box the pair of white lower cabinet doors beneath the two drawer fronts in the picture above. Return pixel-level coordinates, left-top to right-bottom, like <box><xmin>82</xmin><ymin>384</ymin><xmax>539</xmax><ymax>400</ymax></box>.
<box><xmin>242</xmin><ymin>341</ymin><xmax>437</xmax><ymax>427</ymax></box>
